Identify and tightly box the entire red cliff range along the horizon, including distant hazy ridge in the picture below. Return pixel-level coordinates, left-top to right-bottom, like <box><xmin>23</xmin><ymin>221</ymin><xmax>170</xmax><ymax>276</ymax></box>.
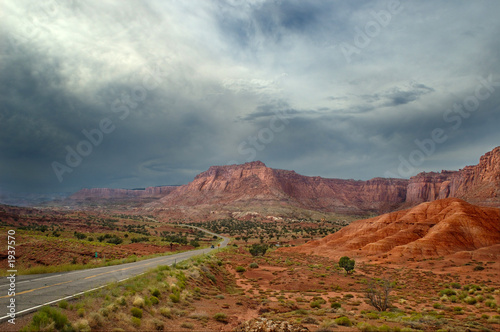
<box><xmin>71</xmin><ymin>147</ymin><xmax>500</xmax><ymax>213</ymax></box>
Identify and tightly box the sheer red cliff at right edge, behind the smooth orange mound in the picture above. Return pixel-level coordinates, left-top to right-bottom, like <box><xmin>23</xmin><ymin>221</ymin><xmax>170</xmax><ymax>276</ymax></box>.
<box><xmin>406</xmin><ymin>147</ymin><xmax>500</xmax><ymax>206</ymax></box>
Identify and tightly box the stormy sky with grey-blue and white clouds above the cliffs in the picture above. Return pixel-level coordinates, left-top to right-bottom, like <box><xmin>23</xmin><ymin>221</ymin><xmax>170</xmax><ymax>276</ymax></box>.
<box><xmin>0</xmin><ymin>0</ymin><xmax>500</xmax><ymax>193</ymax></box>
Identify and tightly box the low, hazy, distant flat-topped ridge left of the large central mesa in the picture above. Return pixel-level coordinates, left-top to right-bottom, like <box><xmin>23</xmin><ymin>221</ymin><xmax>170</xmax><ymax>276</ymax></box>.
<box><xmin>69</xmin><ymin>186</ymin><xmax>176</xmax><ymax>200</ymax></box>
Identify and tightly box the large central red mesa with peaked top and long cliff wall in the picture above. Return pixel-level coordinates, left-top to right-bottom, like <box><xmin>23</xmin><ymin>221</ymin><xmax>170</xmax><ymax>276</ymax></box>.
<box><xmin>154</xmin><ymin>161</ymin><xmax>408</xmax><ymax>212</ymax></box>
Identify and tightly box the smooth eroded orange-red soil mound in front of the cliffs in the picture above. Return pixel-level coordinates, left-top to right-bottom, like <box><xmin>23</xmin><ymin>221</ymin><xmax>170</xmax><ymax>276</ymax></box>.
<box><xmin>281</xmin><ymin>198</ymin><xmax>500</xmax><ymax>260</ymax></box>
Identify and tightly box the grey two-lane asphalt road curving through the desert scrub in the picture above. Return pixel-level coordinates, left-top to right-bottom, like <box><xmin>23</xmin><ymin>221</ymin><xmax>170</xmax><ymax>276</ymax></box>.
<box><xmin>0</xmin><ymin>225</ymin><xmax>229</xmax><ymax>322</ymax></box>
